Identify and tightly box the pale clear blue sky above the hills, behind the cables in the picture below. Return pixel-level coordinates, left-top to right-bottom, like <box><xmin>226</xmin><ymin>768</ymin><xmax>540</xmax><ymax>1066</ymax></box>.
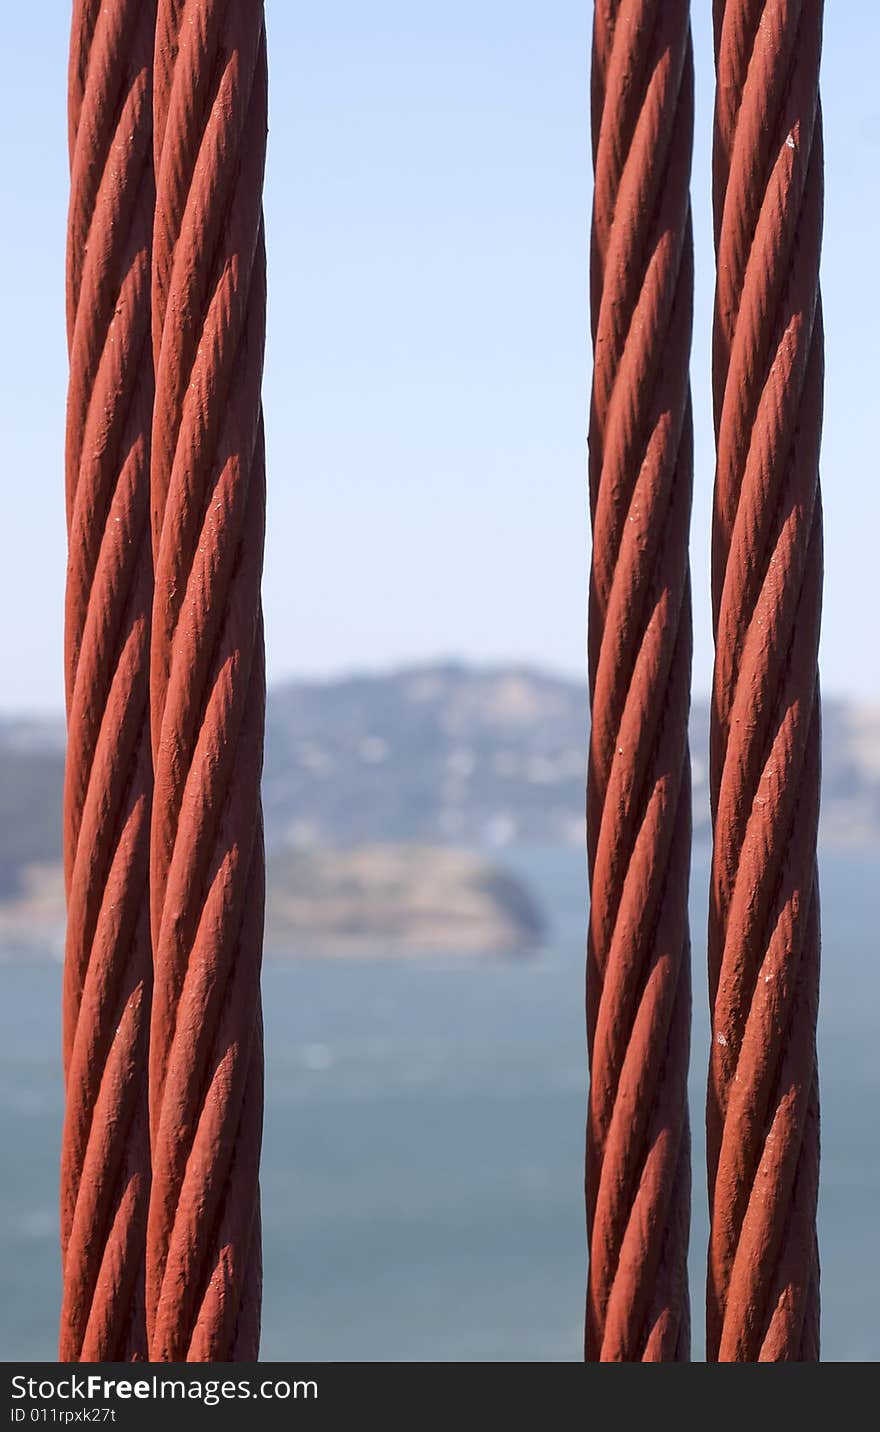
<box><xmin>0</xmin><ymin>0</ymin><xmax>880</xmax><ymax>712</ymax></box>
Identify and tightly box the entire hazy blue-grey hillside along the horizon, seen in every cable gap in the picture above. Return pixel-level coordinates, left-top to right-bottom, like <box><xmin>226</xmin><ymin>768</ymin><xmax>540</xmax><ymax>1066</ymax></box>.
<box><xmin>0</xmin><ymin>666</ymin><xmax>880</xmax><ymax>896</ymax></box>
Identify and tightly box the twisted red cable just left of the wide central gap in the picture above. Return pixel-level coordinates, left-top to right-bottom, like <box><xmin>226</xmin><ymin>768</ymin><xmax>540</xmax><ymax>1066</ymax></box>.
<box><xmin>146</xmin><ymin>0</ymin><xmax>266</xmax><ymax>1362</ymax></box>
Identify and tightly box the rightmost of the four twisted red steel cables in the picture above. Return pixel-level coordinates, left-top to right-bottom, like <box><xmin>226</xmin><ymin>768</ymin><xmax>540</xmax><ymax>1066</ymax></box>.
<box><xmin>707</xmin><ymin>0</ymin><xmax>823</xmax><ymax>1362</ymax></box>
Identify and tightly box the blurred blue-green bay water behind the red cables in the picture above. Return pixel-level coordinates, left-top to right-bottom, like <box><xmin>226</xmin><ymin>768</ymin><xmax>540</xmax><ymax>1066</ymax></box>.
<box><xmin>0</xmin><ymin>849</ymin><xmax>880</xmax><ymax>1362</ymax></box>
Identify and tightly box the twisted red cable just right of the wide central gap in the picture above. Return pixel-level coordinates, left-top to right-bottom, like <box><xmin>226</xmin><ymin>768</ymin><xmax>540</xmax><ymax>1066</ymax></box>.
<box><xmin>585</xmin><ymin>0</ymin><xmax>694</xmax><ymax>1360</ymax></box>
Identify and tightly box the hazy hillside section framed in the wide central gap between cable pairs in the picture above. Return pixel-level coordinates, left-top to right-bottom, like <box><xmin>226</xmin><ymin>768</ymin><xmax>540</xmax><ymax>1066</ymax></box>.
<box><xmin>263</xmin><ymin>666</ymin><xmax>585</xmax><ymax>846</ymax></box>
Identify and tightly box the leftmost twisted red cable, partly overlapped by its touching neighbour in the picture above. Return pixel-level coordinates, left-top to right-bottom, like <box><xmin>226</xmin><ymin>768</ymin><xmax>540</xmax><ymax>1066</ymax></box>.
<box><xmin>59</xmin><ymin>0</ymin><xmax>153</xmax><ymax>1362</ymax></box>
